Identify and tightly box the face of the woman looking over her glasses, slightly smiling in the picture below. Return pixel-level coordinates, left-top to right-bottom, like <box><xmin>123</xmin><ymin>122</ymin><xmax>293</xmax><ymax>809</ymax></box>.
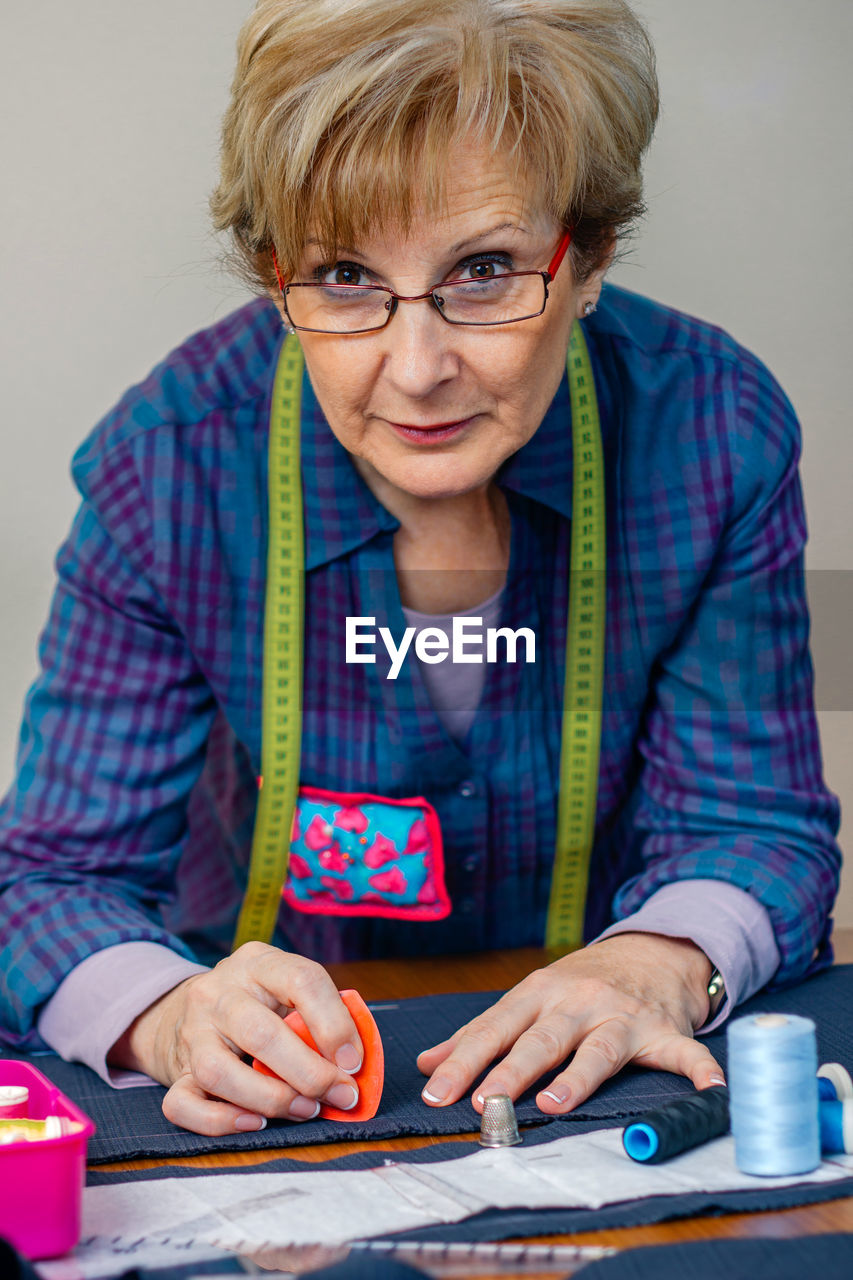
<box><xmin>279</xmin><ymin>148</ymin><xmax>601</xmax><ymax>499</ymax></box>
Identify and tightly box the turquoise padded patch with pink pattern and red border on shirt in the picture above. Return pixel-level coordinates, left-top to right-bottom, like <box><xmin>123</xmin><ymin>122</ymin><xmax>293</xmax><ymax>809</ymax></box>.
<box><xmin>282</xmin><ymin>787</ymin><xmax>451</xmax><ymax>920</ymax></box>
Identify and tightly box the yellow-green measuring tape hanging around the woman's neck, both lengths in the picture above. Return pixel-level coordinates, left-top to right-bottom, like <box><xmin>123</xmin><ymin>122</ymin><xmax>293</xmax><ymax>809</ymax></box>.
<box><xmin>233</xmin><ymin>324</ymin><xmax>606</xmax><ymax>951</ymax></box>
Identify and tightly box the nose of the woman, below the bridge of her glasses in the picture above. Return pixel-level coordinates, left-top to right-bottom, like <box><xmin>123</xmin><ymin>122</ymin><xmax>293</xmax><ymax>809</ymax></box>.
<box><xmin>382</xmin><ymin>298</ymin><xmax>459</xmax><ymax>399</ymax></box>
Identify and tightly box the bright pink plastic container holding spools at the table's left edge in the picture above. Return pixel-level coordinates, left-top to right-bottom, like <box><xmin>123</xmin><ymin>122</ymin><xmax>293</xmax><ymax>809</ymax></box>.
<box><xmin>0</xmin><ymin>1059</ymin><xmax>95</xmax><ymax>1258</ymax></box>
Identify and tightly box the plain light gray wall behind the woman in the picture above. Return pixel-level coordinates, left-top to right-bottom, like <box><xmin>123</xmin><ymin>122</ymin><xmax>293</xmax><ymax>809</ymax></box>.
<box><xmin>0</xmin><ymin>0</ymin><xmax>853</xmax><ymax>925</ymax></box>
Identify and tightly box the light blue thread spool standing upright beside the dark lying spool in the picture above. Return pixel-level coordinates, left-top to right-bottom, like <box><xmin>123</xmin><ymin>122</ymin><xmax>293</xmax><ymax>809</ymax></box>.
<box><xmin>727</xmin><ymin>1014</ymin><xmax>821</xmax><ymax>1178</ymax></box>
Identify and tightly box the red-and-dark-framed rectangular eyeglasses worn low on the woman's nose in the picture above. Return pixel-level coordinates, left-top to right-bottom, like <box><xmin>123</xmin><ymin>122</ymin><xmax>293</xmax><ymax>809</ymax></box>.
<box><xmin>273</xmin><ymin>230</ymin><xmax>571</xmax><ymax>334</ymax></box>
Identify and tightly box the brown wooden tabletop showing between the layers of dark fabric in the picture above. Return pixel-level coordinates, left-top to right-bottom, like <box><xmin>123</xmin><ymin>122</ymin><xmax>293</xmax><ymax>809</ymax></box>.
<box><xmin>97</xmin><ymin>929</ymin><xmax>853</xmax><ymax>1280</ymax></box>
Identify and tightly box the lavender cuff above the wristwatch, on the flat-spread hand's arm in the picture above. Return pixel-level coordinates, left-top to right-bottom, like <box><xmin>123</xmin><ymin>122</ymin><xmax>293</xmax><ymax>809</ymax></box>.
<box><xmin>594</xmin><ymin>879</ymin><xmax>780</xmax><ymax>1034</ymax></box>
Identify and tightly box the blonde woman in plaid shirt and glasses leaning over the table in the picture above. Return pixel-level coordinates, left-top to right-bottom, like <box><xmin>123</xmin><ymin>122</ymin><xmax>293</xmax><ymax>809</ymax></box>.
<box><xmin>0</xmin><ymin>0</ymin><xmax>839</xmax><ymax>1133</ymax></box>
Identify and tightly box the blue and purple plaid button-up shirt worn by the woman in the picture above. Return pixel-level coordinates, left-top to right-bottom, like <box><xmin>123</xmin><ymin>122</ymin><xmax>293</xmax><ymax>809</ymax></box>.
<box><xmin>0</xmin><ymin>287</ymin><xmax>840</xmax><ymax>1047</ymax></box>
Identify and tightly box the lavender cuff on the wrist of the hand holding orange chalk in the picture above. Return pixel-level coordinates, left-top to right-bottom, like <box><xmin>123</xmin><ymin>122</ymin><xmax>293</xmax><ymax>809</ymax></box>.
<box><xmin>38</xmin><ymin>942</ymin><xmax>207</xmax><ymax>1089</ymax></box>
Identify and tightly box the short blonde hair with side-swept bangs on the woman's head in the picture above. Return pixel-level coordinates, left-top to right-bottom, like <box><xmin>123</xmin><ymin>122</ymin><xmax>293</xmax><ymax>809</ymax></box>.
<box><xmin>211</xmin><ymin>0</ymin><xmax>658</xmax><ymax>291</ymax></box>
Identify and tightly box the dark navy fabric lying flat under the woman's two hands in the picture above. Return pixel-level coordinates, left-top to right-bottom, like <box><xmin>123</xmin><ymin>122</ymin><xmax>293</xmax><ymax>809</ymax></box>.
<box><xmin>6</xmin><ymin>965</ymin><xmax>853</xmax><ymax>1164</ymax></box>
